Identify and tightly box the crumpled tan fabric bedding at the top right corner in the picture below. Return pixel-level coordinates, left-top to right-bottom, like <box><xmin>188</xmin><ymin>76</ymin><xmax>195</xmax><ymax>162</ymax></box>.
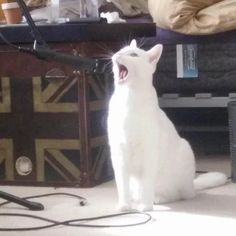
<box><xmin>148</xmin><ymin>0</ymin><xmax>236</xmax><ymax>35</ymax></box>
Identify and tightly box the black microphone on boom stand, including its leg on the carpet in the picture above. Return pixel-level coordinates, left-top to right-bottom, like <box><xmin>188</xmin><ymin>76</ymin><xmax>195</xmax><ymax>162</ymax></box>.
<box><xmin>0</xmin><ymin>0</ymin><xmax>107</xmax><ymax>211</ymax></box>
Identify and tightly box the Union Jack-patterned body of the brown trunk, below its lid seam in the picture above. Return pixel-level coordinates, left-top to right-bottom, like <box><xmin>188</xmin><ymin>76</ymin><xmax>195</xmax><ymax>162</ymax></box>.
<box><xmin>0</xmin><ymin>70</ymin><xmax>113</xmax><ymax>187</ymax></box>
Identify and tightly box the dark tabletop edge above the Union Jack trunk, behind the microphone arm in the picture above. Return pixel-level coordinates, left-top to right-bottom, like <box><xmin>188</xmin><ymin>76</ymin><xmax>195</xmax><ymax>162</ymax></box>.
<box><xmin>0</xmin><ymin>23</ymin><xmax>156</xmax><ymax>43</ymax></box>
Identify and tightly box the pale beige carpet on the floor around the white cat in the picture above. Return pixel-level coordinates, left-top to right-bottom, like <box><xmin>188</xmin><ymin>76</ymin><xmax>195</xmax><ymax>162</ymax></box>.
<box><xmin>0</xmin><ymin>156</ymin><xmax>236</xmax><ymax>236</ymax></box>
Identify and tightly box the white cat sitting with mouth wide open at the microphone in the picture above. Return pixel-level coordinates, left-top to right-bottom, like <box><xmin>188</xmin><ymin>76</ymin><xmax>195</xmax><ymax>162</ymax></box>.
<box><xmin>108</xmin><ymin>40</ymin><xmax>227</xmax><ymax>211</ymax></box>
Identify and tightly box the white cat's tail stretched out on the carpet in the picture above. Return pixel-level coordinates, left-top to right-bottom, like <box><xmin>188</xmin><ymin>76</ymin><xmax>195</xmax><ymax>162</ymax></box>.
<box><xmin>193</xmin><ymin>172</ymin><xmax>227</xmax><ymax>190</ymax></box>
